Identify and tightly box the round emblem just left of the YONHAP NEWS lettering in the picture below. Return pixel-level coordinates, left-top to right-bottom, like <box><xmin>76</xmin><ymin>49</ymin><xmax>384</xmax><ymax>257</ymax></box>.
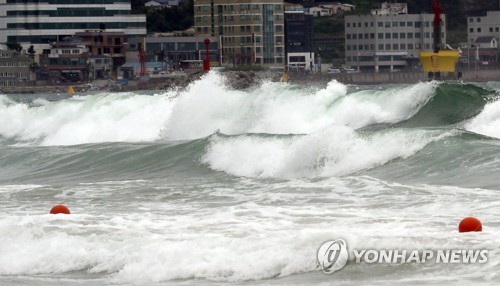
<box><xmin>318</xmin><ymin>239</ymin><xmax>349</xmax><ymax>274</ymax></box>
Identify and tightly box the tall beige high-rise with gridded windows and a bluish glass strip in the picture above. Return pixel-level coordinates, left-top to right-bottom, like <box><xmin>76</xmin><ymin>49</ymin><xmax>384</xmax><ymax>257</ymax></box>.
<box><xmin>194</xmin><ymin>0</ymin><xmax>285</xmax><ymax>68</ymax></box>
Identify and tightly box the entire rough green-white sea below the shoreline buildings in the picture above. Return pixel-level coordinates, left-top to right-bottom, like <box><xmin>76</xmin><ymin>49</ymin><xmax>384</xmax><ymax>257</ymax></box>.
<box><xmin>0</xmin><ymin>73</ymin><xmax>500</xmax><ymax>285</ymax></box>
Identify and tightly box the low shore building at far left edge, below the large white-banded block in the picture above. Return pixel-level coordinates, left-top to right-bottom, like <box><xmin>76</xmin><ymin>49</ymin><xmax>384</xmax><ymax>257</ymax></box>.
<box><xmin>0</xmin><ymin>50</ymin><xmax>34</xmax><ymax>88</ymax></box>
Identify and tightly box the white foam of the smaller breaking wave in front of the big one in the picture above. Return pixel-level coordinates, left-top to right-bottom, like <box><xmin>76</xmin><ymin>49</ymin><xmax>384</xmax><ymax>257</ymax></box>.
<box><xmin>203</xmin><ymin>126</ymin><xmax>454</xmax><ymax>178</ymax></box>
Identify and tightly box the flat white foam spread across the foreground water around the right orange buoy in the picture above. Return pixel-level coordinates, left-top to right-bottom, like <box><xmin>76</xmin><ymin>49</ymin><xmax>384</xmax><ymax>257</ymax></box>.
<box><xmin>0</xmin><ymin>177</ymin><xmax>500</xmax><ymax>285</ymax></box>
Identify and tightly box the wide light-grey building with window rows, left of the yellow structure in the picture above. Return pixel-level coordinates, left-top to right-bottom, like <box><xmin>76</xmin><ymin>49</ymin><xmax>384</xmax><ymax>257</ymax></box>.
<box><xmin>345</xmin><ymin>3</ymin><xmax>446</xmax><ymax>72</ymax></box>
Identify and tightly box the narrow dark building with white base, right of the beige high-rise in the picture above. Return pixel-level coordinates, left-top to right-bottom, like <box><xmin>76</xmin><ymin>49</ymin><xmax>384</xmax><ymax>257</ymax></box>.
<box><xmin>285</xmin><ymin>10</ymin><xmax>315</xmax><ymax>70</ymax></box>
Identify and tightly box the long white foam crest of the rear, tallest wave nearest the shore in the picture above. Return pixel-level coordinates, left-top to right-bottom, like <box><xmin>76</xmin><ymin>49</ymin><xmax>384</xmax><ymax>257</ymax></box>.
<box><xmin>0</xmin><ymin>73</ymin><xmax>434</xmax><ymax>145</ymax></box>
